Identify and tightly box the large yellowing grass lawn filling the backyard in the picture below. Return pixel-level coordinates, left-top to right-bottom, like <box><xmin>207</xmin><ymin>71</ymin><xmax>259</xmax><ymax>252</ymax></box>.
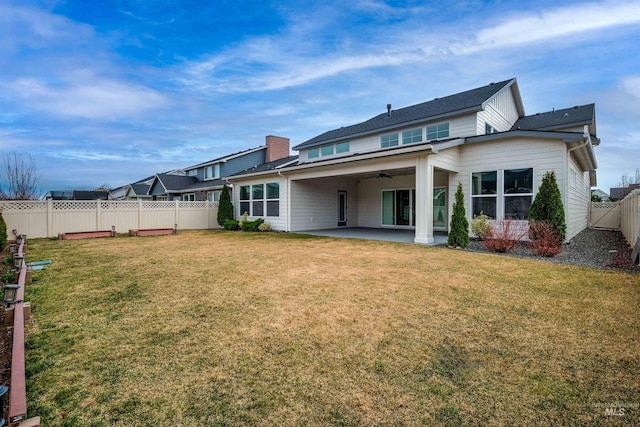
<box><xmin>26</xmin><ymin>231</ymin><xmax>640</xmax><ymax>426</ymax></box>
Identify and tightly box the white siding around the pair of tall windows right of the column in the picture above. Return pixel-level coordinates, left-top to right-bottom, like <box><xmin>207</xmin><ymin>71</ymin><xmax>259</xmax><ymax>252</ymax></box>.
<box><xmin>456</xmin><ymin>138</ymin><xmax>567</xmax><ymax>229</ymax></box>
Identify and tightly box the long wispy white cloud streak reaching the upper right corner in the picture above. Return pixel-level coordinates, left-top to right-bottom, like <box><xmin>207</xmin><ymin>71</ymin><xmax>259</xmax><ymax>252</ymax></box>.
<box><xmin>178</xmin><ymin>1</ymin><xmax>640</xmax><ymax>93</ymax></box>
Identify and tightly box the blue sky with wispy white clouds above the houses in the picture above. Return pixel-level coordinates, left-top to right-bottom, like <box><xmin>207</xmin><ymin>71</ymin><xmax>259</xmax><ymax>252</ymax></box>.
<box><xmin>0</xmin><ymin>0</ymin><xmax>640</xmax><ymax>195</ymax></box>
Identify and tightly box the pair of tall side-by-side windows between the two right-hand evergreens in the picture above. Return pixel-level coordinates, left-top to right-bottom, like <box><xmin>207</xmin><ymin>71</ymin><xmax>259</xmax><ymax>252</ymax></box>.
<box><xmin>471</xmin><ymin>168</ymin><xmax>533</xmax><ymax>220</ymax></box>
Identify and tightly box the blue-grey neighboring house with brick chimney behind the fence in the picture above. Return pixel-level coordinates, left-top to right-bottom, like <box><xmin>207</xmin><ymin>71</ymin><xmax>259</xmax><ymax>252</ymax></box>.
<box><xmin>148</xmin><ymin>135</ymin><xmax>289</xmax><ymax>201</ymax></box>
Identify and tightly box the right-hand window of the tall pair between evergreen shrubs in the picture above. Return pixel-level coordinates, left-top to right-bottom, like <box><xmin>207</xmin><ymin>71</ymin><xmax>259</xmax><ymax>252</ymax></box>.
<box><xmin>504</xmin><ymin>168</ymin><xmax>533</xmax><ymax>220</ymax></box>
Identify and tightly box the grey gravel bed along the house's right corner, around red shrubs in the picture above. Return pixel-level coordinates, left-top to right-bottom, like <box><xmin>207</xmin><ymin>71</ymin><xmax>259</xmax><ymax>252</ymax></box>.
<box><xmin>448</xmin><ymin>228</ymin><xmax>640</xmax><ymax>274</ymax></box>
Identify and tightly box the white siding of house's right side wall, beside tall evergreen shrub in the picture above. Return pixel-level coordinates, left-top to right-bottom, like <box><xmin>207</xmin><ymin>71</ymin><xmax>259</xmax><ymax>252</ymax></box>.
<box><xmin>565</xmin><ymin>158</ymin><xmax>591</xmax><ymax>240</ymax></box>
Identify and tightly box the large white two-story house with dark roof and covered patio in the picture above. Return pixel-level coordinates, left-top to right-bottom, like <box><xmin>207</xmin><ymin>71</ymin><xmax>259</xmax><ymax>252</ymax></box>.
<box><xmin>228</xmin><ymin>78</ymin><xmax>600</xmax><ymax>244</ymax></box>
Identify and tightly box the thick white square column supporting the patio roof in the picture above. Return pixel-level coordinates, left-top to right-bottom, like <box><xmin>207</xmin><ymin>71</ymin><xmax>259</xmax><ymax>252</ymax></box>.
<box><xmin>413</xmin><ymin>155</ymin><xmax>434</xmax><ymax>245</ymax></box>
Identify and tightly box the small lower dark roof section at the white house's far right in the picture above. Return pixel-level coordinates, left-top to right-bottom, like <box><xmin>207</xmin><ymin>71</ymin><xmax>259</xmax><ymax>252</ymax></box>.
<box><xmin>511</xmin><ymin>104</ymin><xmax>595</xmax><ymax>130</ymax></box>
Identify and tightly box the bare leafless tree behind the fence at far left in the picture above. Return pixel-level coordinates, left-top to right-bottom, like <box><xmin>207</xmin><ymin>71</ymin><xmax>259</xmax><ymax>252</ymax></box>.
<box><xmin>0</xmin><ymin>153</ymin><xmax>41</xmax><ymax>200</ymax></box>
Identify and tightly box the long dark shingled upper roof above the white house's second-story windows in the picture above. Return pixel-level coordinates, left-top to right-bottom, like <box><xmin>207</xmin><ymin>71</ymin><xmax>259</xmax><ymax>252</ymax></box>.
<box><xmin>293</xmin><ymin>79</ymin><xmax>516</xmax><ymax>150</ymax></box>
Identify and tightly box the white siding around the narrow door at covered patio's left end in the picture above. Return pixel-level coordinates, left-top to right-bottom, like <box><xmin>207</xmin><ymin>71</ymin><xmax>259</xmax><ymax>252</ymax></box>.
<box><xmin>291</xmin><ymin>177</ymin><xmax>358</xmax><ymax>231</ymax></box>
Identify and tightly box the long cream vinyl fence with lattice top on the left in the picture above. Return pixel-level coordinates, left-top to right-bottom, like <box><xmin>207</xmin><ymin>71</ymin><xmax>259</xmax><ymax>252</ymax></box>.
<box><xmin>0</xmin><ymin>200</ymin><xmax>220</xmax><ymax>238</ymax></box>
